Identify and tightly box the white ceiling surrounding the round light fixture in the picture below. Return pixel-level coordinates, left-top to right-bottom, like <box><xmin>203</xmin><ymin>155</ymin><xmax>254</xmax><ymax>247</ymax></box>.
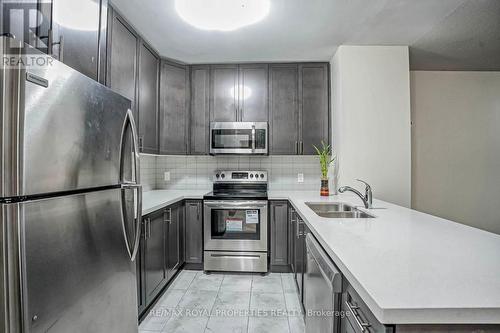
<box><xmin>112</xmin><ymin>0</ymin><xmax>500</xmax><ymax>69</ymax></box>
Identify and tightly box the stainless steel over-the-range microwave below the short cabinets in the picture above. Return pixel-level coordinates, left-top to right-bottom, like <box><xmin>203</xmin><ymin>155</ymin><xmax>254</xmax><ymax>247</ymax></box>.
<box><xmin>210</xmin><ymin>122</ymin><xmax>268</xmax><ymax>155</ymax></box>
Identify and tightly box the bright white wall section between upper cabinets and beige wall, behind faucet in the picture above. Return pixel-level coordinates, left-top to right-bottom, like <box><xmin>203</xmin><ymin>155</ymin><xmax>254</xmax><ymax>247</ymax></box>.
<box><xmin>331</xmin><ymin>46</ymin><xmax>411</xmax><ymax>207</ymax></box>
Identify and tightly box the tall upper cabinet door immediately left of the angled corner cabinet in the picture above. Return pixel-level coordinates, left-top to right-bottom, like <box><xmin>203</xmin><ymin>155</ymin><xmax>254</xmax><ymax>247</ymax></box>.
<box><xmin>138</xmin><ymin>43</ymin><xmax>160</xmax><ymax>154</ymax></box>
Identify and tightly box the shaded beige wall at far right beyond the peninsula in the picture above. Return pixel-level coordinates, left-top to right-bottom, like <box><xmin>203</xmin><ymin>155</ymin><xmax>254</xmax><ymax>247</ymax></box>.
<box><xmin>411</xmin><ymin>71</ymin><xmax>500</xmax><ymax>234</ymax></box>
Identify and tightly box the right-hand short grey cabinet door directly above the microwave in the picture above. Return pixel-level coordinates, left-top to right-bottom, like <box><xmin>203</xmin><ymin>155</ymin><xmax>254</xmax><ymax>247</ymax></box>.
<box><xmin>238</xmin><ymin>64</ymin><xmax>269</xmax><ymax>122</ymax></box>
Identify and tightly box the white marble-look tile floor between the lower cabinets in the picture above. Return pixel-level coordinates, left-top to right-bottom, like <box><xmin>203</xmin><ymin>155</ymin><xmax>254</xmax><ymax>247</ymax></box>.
<box><xmin>139</xmin><ymin>270</ymin><xmax>304</xmax><ymax>333</ymax></box>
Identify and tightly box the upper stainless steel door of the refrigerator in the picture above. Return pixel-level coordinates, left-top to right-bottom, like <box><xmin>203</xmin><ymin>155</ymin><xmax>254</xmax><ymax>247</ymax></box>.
<box><xmin>0</xmin><ymin>39</ymin><xmax>136</xmax><ymax>197</ymax></box>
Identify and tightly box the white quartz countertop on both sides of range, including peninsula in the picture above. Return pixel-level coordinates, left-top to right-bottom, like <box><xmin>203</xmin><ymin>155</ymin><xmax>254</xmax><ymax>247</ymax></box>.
<box><xmin>143</xmin><ymin>191</ymin><xmax>500</xmax><ymax>324</ymax></box>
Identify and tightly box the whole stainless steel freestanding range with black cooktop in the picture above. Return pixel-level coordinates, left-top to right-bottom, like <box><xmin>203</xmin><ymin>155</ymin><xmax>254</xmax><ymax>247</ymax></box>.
<box><xmin>204</xmin><ymin>171</ymin><xmax>268</xmax><ymax>273</ymax></box>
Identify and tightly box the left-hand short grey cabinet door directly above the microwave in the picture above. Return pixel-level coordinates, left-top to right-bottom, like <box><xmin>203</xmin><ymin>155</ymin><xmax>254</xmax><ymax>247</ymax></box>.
<box><xmin>210</xmin><ymin>65</ymin><xmax>238</xmax><ymax>121</ymax></box>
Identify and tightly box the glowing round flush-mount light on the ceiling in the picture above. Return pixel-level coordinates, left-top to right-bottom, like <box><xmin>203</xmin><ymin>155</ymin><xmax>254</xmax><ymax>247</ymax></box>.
<box><xmin>175</xmin><ymin>0</ymin><xmax>271</xmax><ymax>31</ymax></box>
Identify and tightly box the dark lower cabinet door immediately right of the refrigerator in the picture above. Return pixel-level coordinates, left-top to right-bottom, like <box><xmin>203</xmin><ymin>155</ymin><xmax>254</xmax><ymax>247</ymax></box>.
<box><xmin>144</xmin><ymin>211</ymin><xmax>166</xmax><ymax>303</ymax></box>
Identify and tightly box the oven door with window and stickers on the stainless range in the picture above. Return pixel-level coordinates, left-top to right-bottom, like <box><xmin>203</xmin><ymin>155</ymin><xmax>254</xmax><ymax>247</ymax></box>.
<box><xmin>204</xmin><ymin>200</ymin><xmax>267</xmax><ymax>251</ymax></box>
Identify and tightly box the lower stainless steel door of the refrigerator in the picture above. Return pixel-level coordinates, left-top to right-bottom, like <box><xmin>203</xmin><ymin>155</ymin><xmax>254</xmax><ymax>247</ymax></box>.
<box><xmin>19</xmin><ymin>189</ymin><xmax>138</xmax><ymax>333</ymax></box>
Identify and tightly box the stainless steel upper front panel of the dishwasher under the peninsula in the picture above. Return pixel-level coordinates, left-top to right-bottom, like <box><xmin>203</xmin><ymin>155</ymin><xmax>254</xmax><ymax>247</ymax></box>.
<box><xmin>306</xmin><ymin>233</ymin><xmax>342</xmax><ymax>293</ymax></box>
